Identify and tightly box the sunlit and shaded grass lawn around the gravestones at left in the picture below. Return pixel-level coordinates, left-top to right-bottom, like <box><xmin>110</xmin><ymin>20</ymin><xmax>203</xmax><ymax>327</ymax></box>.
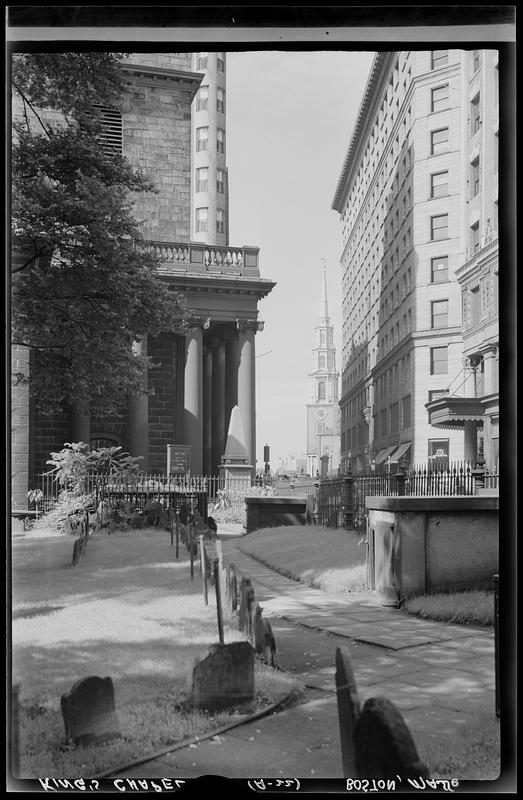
<box><xmin>12</xmin><ymin>528</ymin><xmax>302</xmax><ymax>778</ymax></box>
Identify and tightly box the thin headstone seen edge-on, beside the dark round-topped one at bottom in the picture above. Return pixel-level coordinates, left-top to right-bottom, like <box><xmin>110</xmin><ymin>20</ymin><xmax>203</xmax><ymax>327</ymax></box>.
<box><xmin>336</xmin><ymin>647</ymin><xmax>360</xmax><ymax>778</ymax></box>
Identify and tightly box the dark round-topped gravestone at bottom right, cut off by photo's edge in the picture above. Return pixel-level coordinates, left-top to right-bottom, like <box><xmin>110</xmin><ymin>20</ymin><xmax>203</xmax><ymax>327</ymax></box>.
<box><xmin>354</xmin><ymin>697</ymin><xmax>430</xmax><ymax>780</ymax></box>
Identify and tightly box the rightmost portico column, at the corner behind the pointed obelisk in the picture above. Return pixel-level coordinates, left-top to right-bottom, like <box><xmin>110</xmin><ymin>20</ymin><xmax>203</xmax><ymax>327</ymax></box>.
<box><xmin>236</xmin><ymin>320</ymin><xmax>263</xmax><ymax>473</ymax></box>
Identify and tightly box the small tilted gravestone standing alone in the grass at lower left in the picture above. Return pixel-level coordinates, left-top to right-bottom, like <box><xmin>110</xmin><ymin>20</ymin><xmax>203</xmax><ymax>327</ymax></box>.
<box><xmin>60</xmin><ymin>676</ymin><xmax>121</xmax><ymax>746</ymax></box>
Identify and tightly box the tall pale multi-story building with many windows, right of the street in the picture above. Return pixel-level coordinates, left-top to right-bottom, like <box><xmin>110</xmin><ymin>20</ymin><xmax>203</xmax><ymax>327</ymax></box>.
<box><xmin>333</xmin><ymin>50</ymin><xmax>498</xmax><ymax>468</ymax></box>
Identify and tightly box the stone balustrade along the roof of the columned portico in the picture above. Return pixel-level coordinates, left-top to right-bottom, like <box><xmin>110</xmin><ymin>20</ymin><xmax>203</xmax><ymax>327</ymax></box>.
<box><xmin>137</xmin><ymin>241</ymin><xmax>260</xmax><ymax>277</ymax></box>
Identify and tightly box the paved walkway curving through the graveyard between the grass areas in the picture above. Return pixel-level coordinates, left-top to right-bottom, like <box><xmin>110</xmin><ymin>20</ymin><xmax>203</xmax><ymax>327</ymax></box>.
<box><xmin>114</xmin><ymin>527</ymin><xmax>498</xmax><ymax>788</ymax></box>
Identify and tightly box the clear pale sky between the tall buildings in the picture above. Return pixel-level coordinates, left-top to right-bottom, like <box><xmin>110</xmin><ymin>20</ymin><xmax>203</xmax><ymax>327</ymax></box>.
<box><xmin>226</xmin><ymin>50</ymin><xmax>374</xmax><ymax>468</ymax></box>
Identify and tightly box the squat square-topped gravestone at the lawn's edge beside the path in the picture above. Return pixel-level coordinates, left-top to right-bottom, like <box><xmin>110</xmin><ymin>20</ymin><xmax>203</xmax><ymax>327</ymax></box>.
<box><xmin>192</xmin><ymin>642</ymin><xmax>254</xmax><ymax>711</ymax></box>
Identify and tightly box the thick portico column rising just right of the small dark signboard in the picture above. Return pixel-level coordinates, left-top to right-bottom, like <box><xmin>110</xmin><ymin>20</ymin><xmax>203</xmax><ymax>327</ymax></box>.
<box><xmin>184</xmin><ymin>323</ymin><xmax>208</xmax><ymax>475</ymax></box>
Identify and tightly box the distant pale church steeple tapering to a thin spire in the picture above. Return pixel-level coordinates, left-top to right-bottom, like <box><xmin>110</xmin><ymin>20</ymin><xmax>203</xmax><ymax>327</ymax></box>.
<box><xmin>307</xmin><ymin>260</ymin><xmax>340</xmax><ymax>477</ymax></box>
